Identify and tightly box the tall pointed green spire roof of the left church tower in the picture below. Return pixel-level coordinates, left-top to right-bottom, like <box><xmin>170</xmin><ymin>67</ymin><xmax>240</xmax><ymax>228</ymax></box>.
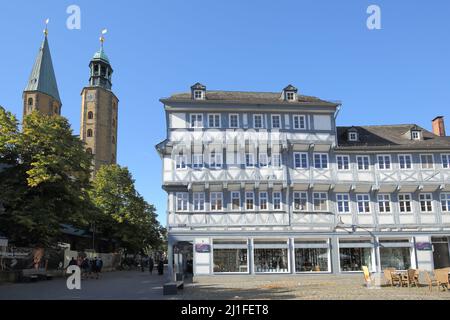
<box><xmin>24</xmin><ymin>36</ymin><xmax>61</xmax><ymax>103</ymax></box>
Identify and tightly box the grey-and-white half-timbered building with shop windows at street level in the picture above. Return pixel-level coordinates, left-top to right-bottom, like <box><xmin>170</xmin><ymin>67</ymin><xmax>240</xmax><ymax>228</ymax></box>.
<box><xmin>156</xmin><ymin>83</ymin><xmax>450</xmax><ymax>275</ymax></box>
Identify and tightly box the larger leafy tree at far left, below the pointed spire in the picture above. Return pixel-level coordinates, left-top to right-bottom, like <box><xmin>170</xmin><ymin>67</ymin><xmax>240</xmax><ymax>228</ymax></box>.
<box><xmin>0</xmin><ymin>110</ymin><xmax>94</xmax><ymax>246</ymax></box>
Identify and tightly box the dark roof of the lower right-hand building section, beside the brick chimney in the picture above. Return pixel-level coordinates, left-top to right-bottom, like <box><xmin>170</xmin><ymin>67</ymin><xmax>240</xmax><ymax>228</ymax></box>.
<box><xmin>337</xmin><ymin>124</ymin><xmax>450</xmax><ymax>150</ymax></box>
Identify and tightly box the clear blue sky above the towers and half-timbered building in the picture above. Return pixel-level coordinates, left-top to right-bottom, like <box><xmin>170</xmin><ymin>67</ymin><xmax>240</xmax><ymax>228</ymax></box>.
<box><xmin>0</xmin><ymin>0</ymin><xmax>450</xmax><ymax>223</ymax></box>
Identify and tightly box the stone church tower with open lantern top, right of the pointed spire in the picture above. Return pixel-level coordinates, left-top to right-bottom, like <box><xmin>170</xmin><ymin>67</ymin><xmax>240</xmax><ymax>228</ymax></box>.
<box><xmin>80</xmin><ymin>36</ymin><xmax>119</xmax><ymax>175</ymax></box>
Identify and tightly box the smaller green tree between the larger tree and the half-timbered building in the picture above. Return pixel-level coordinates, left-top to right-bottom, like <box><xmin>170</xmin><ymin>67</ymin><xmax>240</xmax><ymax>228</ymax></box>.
<box><xmin>91</xmin><ymin>165</ymin><xmax>160</xmax><ymax>253</ymax></box>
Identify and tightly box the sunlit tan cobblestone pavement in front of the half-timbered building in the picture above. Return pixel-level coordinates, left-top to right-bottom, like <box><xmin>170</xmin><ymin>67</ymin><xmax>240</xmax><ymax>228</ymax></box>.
<box><xmin>178</xmin><ymin>274</ymin><xmax>450</xmax><ymax>300</ymax></box>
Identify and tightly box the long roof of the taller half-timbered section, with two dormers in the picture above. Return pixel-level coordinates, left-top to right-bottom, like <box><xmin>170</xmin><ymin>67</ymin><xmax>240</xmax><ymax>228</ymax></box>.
<box><xmin>161</xmin><ymin>90</ymin><xmax>340</xmax><ymax>107</ymax></box>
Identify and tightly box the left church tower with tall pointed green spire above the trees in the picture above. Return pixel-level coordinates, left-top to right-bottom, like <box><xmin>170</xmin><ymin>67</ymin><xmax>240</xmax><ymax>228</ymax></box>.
<box><xmin>22</xmin><ymin>23</ymin><xmax>62</xmax><ymax>117</ymax></box>
